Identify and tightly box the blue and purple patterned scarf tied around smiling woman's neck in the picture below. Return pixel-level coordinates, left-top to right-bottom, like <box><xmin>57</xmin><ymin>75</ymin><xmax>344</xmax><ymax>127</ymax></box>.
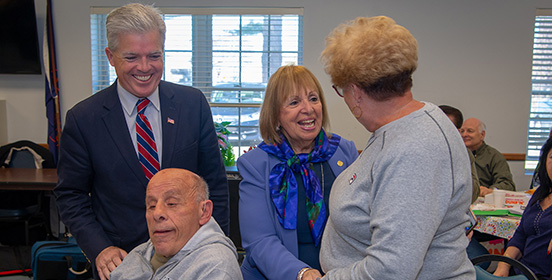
<box><xmin>258</xmin><ymin>129</ymin><xmax>341</xmax><ymax>246</ymax></box>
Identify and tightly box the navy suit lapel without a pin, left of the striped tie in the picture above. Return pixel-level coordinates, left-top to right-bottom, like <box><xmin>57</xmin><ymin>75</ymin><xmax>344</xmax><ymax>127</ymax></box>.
<box><xmin>102</xmin><ymin>83</ymin><xmax>147</xmax><ymax>186</ymax></box>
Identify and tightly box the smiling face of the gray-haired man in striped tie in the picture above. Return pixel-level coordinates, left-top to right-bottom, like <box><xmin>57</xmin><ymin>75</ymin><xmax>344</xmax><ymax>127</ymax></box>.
<box><xmin>105</xmin><ymin>31</ymin><xmax>163</xmax><ymax>98</ymax></box>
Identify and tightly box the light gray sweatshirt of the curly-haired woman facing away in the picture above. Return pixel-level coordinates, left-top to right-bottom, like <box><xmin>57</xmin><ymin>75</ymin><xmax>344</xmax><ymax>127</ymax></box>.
<box><xmin>320</xmin><ymin>103</ymin><xmax>475</xmax><ymax>280</ymax></box>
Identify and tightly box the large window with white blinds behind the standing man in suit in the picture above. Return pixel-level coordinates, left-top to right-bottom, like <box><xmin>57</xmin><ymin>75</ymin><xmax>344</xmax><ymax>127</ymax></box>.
<box><xmin>90</xmin><ymin>8</ymin><xmax>303</xmax><ymax>156</ymax></box>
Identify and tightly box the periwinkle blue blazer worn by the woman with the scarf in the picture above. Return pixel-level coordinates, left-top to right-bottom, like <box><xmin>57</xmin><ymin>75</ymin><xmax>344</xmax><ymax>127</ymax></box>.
<box><xmin>237</xmin><ymin>135</ymin><xmax>358</xmax><ymax>280</ymax></box>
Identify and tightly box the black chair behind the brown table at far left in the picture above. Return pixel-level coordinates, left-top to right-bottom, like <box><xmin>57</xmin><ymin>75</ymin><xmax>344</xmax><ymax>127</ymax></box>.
<box><xmin>0</xmin><ymin>140</ymin><xmax>55</xmax><ymax>245</ymax></box>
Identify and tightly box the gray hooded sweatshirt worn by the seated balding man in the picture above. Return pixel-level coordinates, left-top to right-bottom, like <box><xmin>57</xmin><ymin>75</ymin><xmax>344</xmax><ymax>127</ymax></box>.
<box><xmin>110</xmin><ymin>217</ymin><xmax>243</xmax><ymax>280</ymax></box>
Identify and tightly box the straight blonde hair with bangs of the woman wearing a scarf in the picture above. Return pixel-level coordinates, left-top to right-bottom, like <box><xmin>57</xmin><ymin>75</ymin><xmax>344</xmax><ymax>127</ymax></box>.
<box><xmin>259</xmin><ymin>65</ymin><xmax>329</xmax><ymax>144</ymax></box>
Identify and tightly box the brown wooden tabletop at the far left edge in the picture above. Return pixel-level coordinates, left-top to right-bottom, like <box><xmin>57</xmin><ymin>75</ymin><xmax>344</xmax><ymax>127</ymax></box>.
<box><xmin>0</xmin><ymin>168</ymin><xmax>58</xmax><ymax>191</ymax></box>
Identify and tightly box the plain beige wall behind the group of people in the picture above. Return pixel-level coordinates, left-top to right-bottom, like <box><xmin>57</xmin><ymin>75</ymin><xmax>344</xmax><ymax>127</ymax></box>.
<box><xmin>0</xmin><ymin>0</ymin><xmax>552</xmax><ymax>189</ymax></box>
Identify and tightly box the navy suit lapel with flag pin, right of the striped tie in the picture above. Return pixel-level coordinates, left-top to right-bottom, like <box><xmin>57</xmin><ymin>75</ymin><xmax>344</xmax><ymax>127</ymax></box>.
<box><xmin>159</xmin><ymin>81</ymin><xmax>182</xmax><ymax>169</ymax></box>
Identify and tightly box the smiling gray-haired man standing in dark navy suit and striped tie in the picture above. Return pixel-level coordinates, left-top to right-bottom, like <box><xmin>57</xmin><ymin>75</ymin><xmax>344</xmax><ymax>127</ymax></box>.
<box><xmin>54</xmin><ymin>4</ymin><xmax>229</xmax><ymax>279</ymax></box>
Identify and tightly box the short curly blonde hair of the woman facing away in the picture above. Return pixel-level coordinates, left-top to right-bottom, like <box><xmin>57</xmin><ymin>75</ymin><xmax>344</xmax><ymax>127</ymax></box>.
<box><xmin>321</xmin><ymin>16</ymin><xmax>418</xmax><ymax>101</ymax></box>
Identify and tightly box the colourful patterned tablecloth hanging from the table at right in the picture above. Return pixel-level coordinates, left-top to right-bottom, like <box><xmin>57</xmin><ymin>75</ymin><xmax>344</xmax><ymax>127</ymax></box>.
<box><xmin>474</xmin><ymin>213</ymin><xmax>521</xmax><ymax>239</ymax></box>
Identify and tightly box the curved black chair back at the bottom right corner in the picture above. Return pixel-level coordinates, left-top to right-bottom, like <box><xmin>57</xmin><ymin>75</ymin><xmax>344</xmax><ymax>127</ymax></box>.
<box><xmin>471</xmin><ymin>254</ymin><xmax>539</xmax><ymax>280</ymax></box>
